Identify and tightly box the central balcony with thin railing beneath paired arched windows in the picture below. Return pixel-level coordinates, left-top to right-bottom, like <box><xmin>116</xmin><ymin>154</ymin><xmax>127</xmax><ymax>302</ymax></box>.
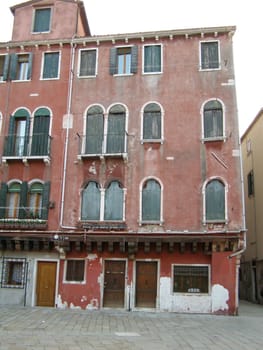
<box><xmin>78</xmin><ymin>134</ymin><xmax>127</xmax><ymax>160</ymax></box>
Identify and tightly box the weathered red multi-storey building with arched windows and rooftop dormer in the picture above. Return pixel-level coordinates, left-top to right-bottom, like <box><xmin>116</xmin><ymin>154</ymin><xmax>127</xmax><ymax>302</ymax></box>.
<box><xmin>0</xmin><ymin>0</ymin><xmax>248</xmax><ymax>314</ymax></box>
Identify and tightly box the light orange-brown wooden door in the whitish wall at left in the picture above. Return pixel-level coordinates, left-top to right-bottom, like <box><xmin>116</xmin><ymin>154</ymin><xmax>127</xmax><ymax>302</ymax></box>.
<box><xmin>36</xmin><ymin>261</ymin><xmax>57</xmax><ymax>306</ymax></box>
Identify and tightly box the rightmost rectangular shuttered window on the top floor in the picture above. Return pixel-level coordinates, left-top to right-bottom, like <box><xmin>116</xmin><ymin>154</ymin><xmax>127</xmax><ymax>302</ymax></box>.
<box><xmin>201</xmin><ymin>41</ymin><xmax>220</xmax><ymax>69</ymax></box>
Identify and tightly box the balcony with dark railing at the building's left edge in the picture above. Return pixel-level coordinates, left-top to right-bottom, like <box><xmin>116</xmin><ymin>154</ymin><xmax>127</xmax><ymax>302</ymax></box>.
<box><xmin>2</xmin><ymin>133</ymin><xmax>51</xmax><ymax>164</ymax></box>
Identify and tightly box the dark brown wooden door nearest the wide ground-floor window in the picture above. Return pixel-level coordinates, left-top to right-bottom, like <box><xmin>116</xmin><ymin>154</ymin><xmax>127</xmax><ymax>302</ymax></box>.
<box><xmin>135</xmin><ymin>261</ymin><xmax>157</xmax><ymax>308</ymax></box>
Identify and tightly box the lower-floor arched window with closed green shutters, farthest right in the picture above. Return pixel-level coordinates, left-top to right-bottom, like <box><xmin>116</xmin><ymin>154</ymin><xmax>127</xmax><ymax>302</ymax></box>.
<box><xmin>205</xmin><ymin>179</ymin><xmax>226</xmax><ymax>221</ymax></box>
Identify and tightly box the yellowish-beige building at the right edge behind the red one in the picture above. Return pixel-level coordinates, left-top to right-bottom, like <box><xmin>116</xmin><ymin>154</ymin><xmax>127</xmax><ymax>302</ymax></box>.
<box><xmin>240</xmin><ymin>109</ymin><xmax>263</xmax><ymax>304</ymax></box>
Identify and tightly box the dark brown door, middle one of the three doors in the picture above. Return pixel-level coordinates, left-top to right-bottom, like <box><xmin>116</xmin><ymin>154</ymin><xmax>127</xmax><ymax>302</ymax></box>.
<box><xmin>103</xmin><ymin>260</ymin><xmax>125</xmax><ymax>307</ymax></box>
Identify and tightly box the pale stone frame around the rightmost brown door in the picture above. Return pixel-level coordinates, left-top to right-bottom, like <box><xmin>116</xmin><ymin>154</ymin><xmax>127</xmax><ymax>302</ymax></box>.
<box><xmin>131</xmin><ymin>259</ymin><xmax>160</xmax><ymax>311</ymax></box>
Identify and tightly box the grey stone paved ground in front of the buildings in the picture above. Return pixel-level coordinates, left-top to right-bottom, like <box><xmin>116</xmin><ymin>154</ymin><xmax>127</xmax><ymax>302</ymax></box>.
<box><xmin>0</xmin><ymin>302</ymin><xmax>263</xmax><ymax>350</ymax></box>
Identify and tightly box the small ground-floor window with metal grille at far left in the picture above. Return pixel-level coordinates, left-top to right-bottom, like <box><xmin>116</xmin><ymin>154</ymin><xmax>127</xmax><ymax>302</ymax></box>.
<box><xmin>1</xmin><ymin>258</ymin><xmax>26</xmax><ymax>288</ymax></box>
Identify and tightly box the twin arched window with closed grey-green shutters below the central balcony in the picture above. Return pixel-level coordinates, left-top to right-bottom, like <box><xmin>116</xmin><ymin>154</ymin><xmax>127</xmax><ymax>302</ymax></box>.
<box><xmin>81</xmin><ymin>181</ymin><xmax>124</xmax><ymax>221</ymax></box>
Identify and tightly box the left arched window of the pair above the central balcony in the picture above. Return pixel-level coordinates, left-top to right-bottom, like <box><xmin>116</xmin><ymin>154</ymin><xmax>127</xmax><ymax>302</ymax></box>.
<box><xmin>85</xmin><ymin>106</ymin><xmax>104</xmax><ymax>154</ymax></box>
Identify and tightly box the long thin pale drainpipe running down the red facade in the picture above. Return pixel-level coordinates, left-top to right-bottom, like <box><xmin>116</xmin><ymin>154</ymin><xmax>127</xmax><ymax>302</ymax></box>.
<box><xmin>59</xmin><ymin>35</ymin><xmax>76</xmax><ymax>230</ymax></box>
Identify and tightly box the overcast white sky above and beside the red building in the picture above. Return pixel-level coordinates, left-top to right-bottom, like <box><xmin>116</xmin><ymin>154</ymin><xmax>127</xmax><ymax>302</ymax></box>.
<box><xmin>0</xmin><ymin>0</ymin><xmax>263</xmax><ymax>136</ymax></box>
